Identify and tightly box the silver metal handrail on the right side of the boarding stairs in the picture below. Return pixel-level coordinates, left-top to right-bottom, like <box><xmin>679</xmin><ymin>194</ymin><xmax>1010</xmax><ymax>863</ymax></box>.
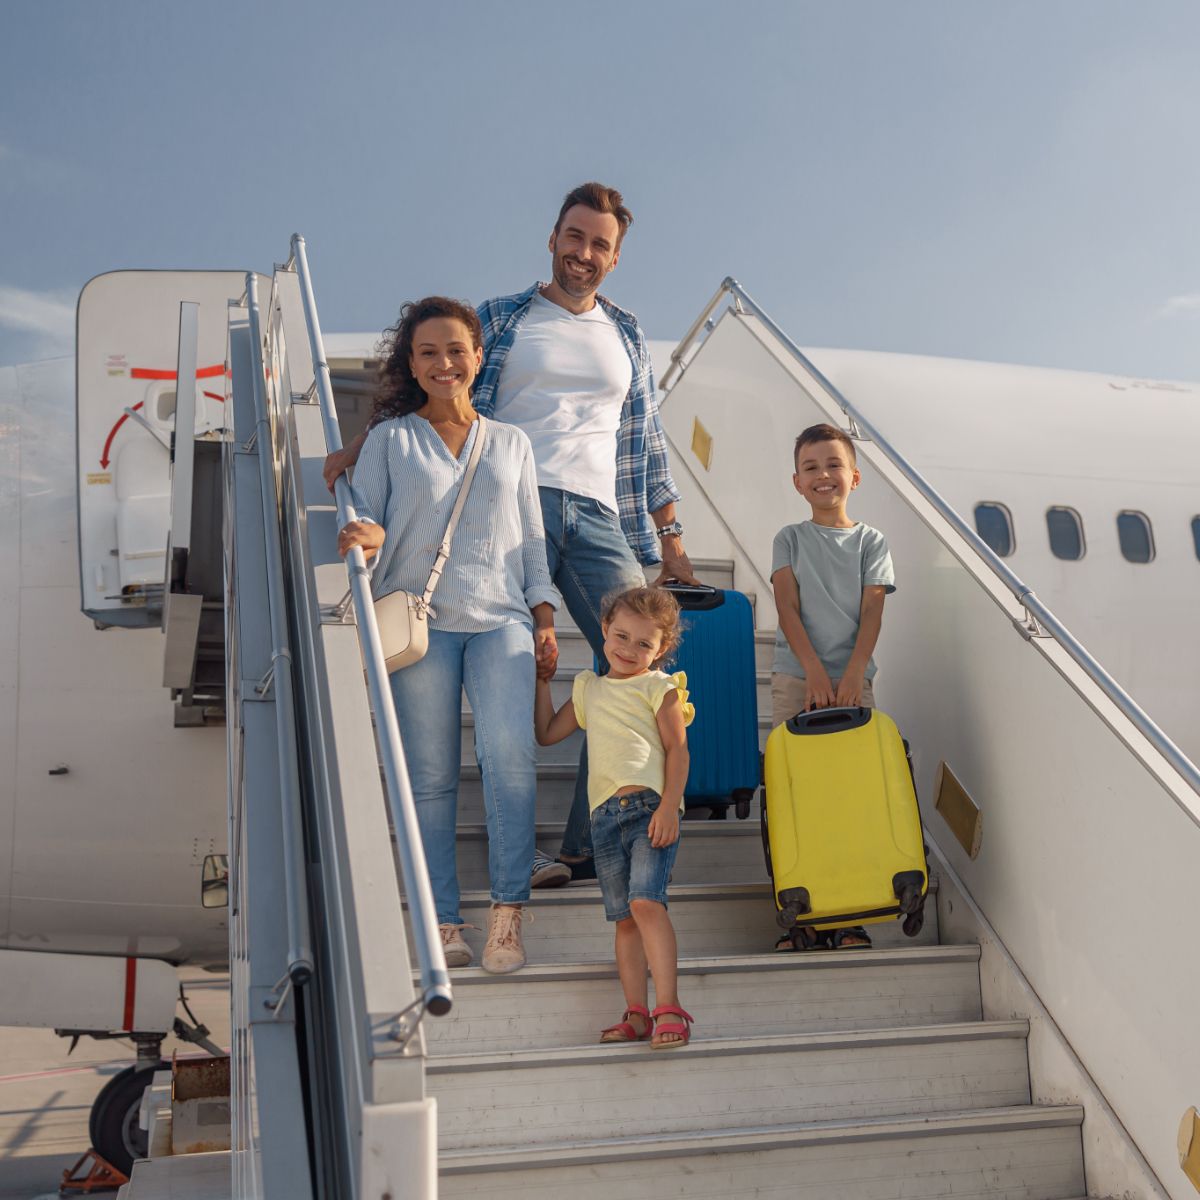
<box><xmin>661</xmin><ymin>276</ymin><xmax>1200</xmax><ymax>824</ymax></box>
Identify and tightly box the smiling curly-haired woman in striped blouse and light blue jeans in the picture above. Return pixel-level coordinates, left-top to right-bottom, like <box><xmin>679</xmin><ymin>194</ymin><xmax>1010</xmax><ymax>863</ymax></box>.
<box><xmin>337</xmin><ymin>296</ymin><xmax>558</xmax><ymax>973</ymax></box>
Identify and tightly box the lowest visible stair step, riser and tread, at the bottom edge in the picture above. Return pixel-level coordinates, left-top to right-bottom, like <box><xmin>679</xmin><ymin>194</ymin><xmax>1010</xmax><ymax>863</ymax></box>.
<box><xmin>439</xmin><ymin>1105</ymin><xmax>1086</xmax><ymax>1200</ymax></box>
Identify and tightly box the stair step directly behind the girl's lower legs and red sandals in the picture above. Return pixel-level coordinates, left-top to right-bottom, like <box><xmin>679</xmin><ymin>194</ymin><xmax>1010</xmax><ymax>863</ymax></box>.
<box><xmin>424</xmin><ymin>946</ymin><xmax>983</xmax><ymax>1055</ymax></box>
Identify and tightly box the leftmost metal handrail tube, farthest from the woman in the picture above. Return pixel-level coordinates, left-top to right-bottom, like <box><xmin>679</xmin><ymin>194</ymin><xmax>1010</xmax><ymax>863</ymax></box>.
<box><xmin>246</xmin><ymin>271</ymin><xmax>313</xmax><ymax>986</ymax></box>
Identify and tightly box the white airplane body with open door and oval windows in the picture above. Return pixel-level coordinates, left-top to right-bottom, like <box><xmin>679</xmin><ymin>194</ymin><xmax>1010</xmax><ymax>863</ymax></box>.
<box><xmin>0</xmin><ymin>272</ymin><xmax>1200</xmax><ymax>1180</ymax></box>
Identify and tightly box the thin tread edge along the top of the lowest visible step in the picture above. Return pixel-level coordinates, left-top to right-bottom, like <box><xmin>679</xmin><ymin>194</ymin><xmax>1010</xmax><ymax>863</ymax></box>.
<box><xmin>438</xmin><ymin>1104</ymin><xmax>1084</xmax><ymax>1175</ymax></box>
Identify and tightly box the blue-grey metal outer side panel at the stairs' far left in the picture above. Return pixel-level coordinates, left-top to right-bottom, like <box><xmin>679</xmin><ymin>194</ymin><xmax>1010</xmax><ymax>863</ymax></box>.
<box><xmin>222</xmin><ymin>304</ymin><xmax>313</xmax><ymax>1200</ymax></box>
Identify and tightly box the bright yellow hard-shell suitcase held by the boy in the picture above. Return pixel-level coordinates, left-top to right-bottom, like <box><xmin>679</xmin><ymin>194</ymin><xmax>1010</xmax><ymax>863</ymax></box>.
<box><xmin>762</xmin><ymin>708</ymin><xmax>929</xmax><ymax>948</ymax></box>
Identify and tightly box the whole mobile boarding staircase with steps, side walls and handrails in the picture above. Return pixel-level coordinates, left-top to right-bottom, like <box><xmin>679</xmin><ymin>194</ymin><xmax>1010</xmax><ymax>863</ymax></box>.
<box><xmin>131</xmin><ymin>248</ymin><xmax>1200</xmax><ymax>1200</ymax></box>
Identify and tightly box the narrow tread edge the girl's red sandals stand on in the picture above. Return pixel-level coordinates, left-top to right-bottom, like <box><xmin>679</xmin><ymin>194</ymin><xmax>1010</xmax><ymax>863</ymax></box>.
<box><xmin>425</xmin><ymin>1020</ymin><xmax>1030</xmax><ymax>1075</ymax></box>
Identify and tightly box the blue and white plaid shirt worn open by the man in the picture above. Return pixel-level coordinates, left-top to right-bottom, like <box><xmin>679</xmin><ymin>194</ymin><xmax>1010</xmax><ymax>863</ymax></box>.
<box><xmin>472</xmin><ymin>283</ymin><xmax>679</xmax><ymax>565</ymax></box>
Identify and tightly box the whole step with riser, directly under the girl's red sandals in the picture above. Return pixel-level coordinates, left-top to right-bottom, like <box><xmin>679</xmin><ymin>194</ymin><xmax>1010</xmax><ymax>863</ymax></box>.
<box><xmin>426</xmin><ymin>1021</ymin><xmax>1030</xmax><ymax>1150</ymax></box>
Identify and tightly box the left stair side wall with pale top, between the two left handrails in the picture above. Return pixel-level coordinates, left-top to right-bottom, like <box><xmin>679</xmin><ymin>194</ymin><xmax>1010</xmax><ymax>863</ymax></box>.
<box><xmin>268</xmin><ymin>270</ymin><xmax>437</xmax><ymax>1200</ymax></box>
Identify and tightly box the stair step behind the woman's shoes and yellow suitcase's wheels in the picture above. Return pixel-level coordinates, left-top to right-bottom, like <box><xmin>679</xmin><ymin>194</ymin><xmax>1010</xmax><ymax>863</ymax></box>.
<box><xmin>409</xmin><ymin>877</ymin><xmax>937</xmax><ymax>964</ymax></box>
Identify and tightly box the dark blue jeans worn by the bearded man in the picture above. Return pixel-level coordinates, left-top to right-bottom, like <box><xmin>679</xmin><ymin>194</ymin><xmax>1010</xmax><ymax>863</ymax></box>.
<box><xmin>538</xmin><ymin>487</ymin><xmax>646</xmax><ymax>858</ymax></box>
